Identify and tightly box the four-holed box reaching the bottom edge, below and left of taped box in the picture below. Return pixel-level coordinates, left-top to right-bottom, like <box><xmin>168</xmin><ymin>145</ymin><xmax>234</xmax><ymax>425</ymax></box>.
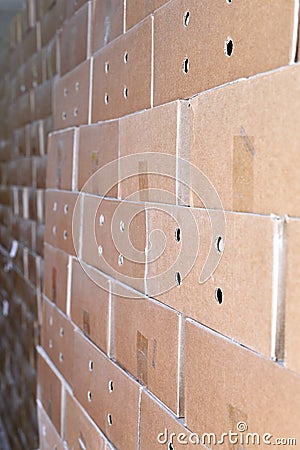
<box><xmin>74</xmin><ymin>332</ymin><xmax>140</xmax><ymax>450</ymax></box>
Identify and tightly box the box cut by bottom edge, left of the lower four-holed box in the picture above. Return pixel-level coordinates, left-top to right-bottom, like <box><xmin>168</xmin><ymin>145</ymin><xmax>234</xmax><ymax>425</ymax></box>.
<box><xmin>64</xmin><ymin>391</ymin><xmax>105</xmax><ymax>450</ymax></box>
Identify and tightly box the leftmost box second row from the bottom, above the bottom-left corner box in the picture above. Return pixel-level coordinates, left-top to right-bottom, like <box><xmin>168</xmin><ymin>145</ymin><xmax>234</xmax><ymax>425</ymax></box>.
<box><xmin>37</xmin><ymin>347</ymin><xmax>62</xmax><ymax>434</ymax></box>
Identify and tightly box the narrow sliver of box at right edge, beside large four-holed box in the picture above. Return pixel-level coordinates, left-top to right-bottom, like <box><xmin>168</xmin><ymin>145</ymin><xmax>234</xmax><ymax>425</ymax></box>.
<box><xmin>281</xmin><ymin>219</ymin><xmax>300</xmax><ymax>373</ymax></box>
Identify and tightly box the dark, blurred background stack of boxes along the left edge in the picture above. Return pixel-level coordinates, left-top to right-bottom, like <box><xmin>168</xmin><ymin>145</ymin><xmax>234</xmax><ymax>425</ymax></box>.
<box><xmin>0</xmin><ymin>0</ymin><xmax>67</xmax><ymax>449</ymax></box>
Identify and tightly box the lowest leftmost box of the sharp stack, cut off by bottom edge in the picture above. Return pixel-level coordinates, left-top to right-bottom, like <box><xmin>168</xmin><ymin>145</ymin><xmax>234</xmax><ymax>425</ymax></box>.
<box><xmin>37</xmin><ymin>401</ymin><xmax>64</xmax><ymax>450</ymax></box>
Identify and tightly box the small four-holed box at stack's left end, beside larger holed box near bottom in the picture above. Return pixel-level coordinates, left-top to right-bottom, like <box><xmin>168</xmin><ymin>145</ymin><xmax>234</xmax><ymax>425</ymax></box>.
<box><xmin>41</xmin><ymin>298</ymin><xmax>76</xmax><ymax>386</ymax></box>
